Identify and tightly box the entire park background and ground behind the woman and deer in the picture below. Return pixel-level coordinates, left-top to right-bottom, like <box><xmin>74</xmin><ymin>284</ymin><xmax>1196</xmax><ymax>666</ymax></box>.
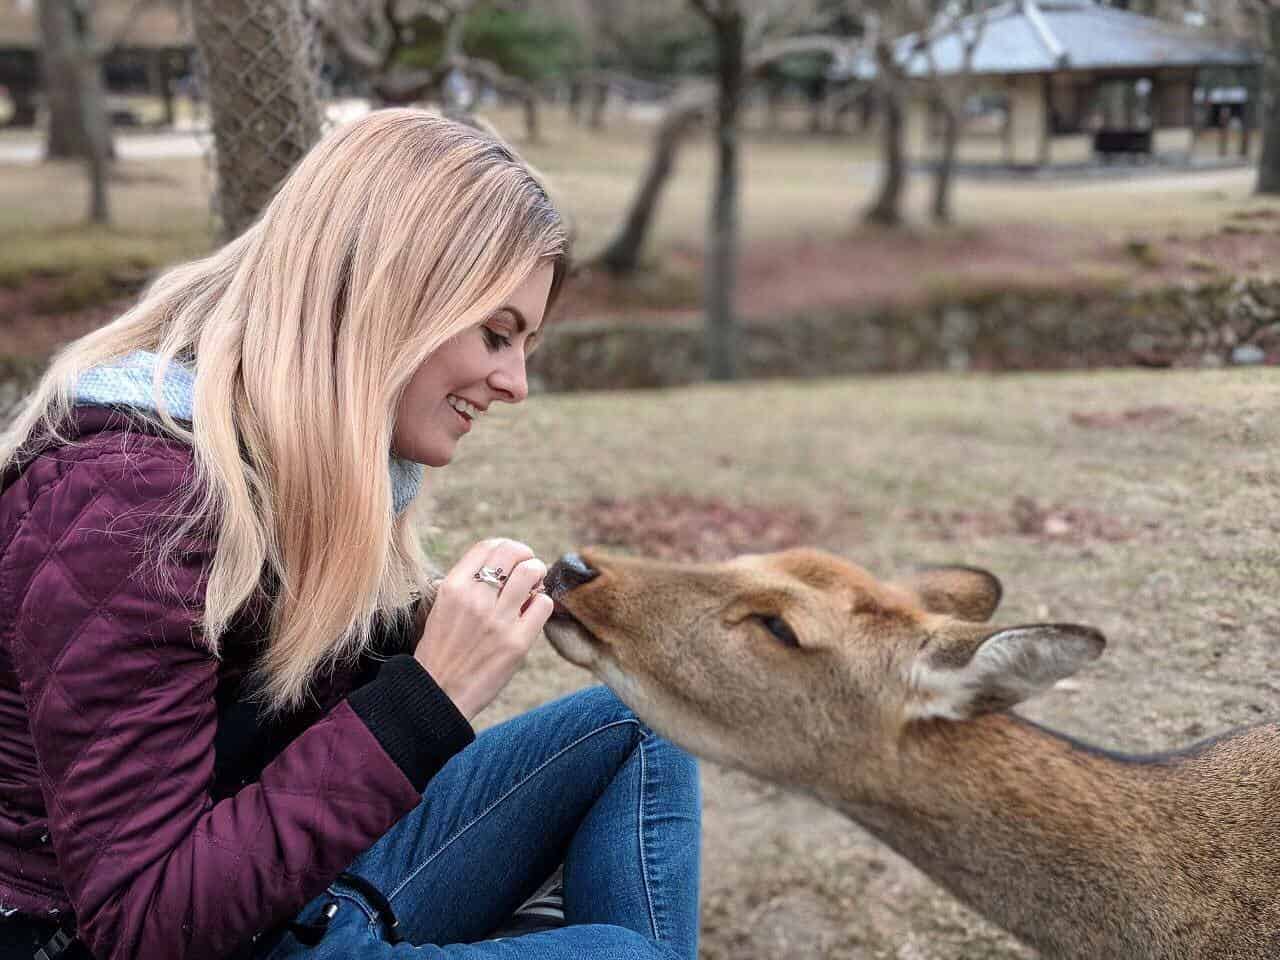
<box><xmin>0</xmin><ymin>0</ymin><xmax>1280</xmax><ymax>960</ymax></box>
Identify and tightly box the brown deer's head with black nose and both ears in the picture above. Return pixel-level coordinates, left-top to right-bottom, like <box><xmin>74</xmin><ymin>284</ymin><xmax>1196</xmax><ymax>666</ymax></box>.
<box><xmin>547</xmin><ymin>549</ymin><xmax>1105</xmax><ymax>786</ymax></box>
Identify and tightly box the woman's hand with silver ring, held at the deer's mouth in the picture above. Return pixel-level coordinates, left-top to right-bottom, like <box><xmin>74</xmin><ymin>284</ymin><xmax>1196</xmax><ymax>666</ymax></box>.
<box><xmin>413</xmin><ymin>540</ymin><xmax>553</xmax><ymax>719</ymax></box>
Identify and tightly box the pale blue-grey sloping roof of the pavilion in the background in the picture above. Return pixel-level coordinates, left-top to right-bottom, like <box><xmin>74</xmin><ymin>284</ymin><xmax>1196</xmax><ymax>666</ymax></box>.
<box><xmin>850</xmin><ymin>0</ymin><xmax>1262</xmax><ymax>77</ymax></box>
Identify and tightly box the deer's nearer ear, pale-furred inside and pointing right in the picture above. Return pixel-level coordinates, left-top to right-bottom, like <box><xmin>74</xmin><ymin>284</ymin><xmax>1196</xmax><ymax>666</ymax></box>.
<box><xmin>908</xmin><ymin>623</ymin><xmax>1106</xmax><ymax>719</ymax></box>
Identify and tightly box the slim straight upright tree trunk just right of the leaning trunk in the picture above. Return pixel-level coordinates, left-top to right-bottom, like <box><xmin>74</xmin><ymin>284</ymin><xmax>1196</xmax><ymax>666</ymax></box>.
<box><xmin>707</xmin><ymin>9</ymin><xmax>745</xmax><ymax>380</ymax></box>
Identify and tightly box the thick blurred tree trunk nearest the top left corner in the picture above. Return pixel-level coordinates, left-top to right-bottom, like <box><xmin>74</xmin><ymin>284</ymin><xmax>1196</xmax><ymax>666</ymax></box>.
<box><xmin>40</xmin><ymin>0</ymin><xmax>115</xmax><ymax>160</ymax></box>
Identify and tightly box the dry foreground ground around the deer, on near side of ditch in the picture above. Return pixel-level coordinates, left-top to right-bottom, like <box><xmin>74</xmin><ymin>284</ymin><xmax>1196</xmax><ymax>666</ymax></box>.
<box><xmin>430</xmin><ymin>370</ymin><xmax>1280</xmax><ymax>960</ymax></box>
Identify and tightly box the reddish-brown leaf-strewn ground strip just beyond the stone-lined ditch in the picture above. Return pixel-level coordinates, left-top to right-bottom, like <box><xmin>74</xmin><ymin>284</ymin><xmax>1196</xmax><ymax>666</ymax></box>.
<box><xmin>556</xmin><ymin>215</ymin><xmax>1280</xmax><ymax>321</ymax></box>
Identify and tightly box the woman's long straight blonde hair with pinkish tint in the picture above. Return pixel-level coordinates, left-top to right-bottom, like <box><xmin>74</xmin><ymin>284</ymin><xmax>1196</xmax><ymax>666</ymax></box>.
<box><xmin>0</xmin><ymin>109</ymin><xmax>568</xmax><ymax>709</ymax></box>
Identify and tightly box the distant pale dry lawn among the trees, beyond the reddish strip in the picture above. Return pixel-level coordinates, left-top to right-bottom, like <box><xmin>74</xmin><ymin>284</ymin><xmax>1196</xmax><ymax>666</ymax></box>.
<box><xmin>0</xmin><ymin>109</ymin><xmax>1274</xmax><ymax>313</ymax></box>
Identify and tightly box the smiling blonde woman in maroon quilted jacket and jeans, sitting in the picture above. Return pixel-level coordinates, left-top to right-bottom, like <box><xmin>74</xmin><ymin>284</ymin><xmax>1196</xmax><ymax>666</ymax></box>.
<box><xmin>0</xmin><ymin>110</ymin><xmax>699</xmax><ymax>960</ymax></box>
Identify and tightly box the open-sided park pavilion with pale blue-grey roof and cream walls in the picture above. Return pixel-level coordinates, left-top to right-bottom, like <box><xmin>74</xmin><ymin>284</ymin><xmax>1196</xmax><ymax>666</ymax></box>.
<box><xmin>899</xmin><ymin>0</ymin><xmax>1262</xmax><ymax>166</ymax></box>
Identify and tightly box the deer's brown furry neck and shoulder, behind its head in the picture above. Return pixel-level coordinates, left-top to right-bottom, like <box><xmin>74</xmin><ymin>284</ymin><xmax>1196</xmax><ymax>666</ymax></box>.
<box><xmin>819</xmin><ymin>714</ymin><xmax>1280</xmax><ymax>960</ymax></box>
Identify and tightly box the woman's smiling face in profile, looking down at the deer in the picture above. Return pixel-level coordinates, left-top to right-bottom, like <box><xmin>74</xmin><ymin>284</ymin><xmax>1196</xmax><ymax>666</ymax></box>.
<box><xmin>392</xmin><ymin>264</ymin><xmax>554</xmax><ymax>467</ymax></box>
